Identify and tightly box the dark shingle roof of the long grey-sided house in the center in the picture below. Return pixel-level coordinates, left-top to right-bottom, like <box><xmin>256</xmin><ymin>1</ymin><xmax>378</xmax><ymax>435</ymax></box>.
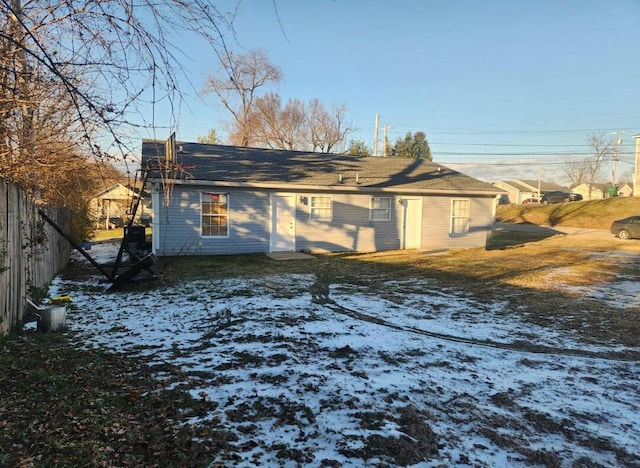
<box><xmin>142</xmin><ymin>140</ymin><xmax>502</xmax><ymax>195</ymax></box>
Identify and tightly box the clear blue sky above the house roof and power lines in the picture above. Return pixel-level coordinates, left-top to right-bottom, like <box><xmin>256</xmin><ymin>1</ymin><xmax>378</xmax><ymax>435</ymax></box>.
<box><xmin>144</xmin><ymin>0</ymin><xmax>640</xmax><ymax>183</ymax></box>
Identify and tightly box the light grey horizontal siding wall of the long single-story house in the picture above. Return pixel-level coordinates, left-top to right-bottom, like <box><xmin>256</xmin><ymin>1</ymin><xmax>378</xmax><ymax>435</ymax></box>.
<box><xmin>153</xmin><ymin>186</ymin><xmax>496</xmax><ymax>256</ymax></box>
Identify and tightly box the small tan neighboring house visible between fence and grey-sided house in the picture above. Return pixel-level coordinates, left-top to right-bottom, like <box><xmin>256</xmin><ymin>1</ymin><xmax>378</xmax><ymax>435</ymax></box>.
<box><xmin>89</xmin><ymin>184</ymin><xmax>153</xmax><ymax>229</ymax></box>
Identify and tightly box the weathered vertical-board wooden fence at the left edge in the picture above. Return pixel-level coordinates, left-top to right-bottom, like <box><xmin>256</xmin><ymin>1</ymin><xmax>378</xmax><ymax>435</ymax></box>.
<box><xmin>0</xmin><ymin>178</ymin><xmax>71</xmax><ymax>335</ymax></box>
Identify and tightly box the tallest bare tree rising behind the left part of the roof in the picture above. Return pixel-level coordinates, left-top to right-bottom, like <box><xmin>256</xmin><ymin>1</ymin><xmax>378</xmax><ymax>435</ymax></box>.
<box><xmin>203</xmin><ymin>50</ymin><xmax>282</xmax><ymax>146</ymax></box>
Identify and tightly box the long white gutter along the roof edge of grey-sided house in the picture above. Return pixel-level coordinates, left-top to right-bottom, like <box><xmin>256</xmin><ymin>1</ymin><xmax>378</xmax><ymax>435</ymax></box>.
<box><xmin>148</xmin><ymin>179</ymin><xmax>505</xmax><ymax>196</ymax></box>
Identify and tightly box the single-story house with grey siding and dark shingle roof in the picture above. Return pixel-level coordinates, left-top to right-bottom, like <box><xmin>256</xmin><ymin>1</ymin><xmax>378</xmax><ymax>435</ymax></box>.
<box><xmin>142</xmin><ymin>140</ymin><xmax>502</xmax><ymax>256</ymax></box>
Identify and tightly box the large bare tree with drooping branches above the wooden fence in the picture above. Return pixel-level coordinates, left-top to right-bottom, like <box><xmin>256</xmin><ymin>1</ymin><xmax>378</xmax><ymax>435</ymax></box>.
<box><xmin>0</xmin><ymin>0</ymin><xmax>239</xmax><ymax>239</ymax></box>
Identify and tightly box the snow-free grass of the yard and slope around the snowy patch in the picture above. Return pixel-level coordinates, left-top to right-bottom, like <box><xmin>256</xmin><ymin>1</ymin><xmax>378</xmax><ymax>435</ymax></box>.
<box><xmin>0</xmin><ymin>218</ymin><xmax>640</xmax><ymax>467</ymax></box>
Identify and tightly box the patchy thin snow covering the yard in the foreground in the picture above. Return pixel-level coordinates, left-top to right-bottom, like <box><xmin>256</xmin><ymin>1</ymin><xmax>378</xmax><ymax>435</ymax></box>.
<box><xmin>42</xmin><ymin>245</ymin><xmax>640</xmax><ymax>467</ymax></box>
